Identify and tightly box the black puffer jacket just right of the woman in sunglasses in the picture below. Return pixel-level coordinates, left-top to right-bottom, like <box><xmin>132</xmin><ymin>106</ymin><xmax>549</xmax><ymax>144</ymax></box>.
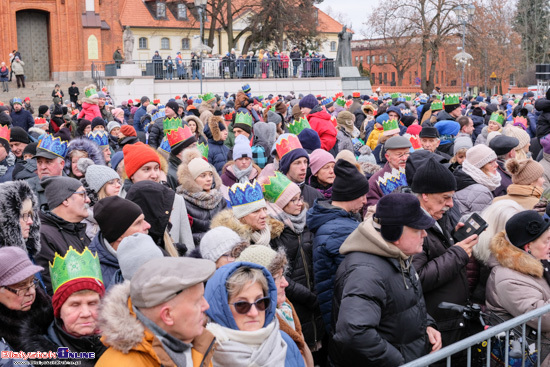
<box><xmin>271</xmin><ymin>226</ymin><xmax>325</xmax><ymax>346</ymax></box>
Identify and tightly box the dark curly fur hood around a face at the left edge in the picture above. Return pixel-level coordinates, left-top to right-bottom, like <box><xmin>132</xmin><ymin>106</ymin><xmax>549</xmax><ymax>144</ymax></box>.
<box><xmin>0</xmin><ymin>181</ymin><xmax>40</xmax><ymax>256</ymax></box>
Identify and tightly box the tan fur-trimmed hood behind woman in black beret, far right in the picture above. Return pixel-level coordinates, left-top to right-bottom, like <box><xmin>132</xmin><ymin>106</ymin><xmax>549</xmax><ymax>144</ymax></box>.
<box><xmin>489</xmin><ymin>231</ymin><xmax>544</xmax><ymax>278</ymax></box>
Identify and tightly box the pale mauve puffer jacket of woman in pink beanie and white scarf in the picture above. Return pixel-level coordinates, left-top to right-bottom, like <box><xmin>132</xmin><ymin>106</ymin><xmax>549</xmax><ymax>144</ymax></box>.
<box><xmin>453</xmin><ymin>168</ymin><xmax>493</xmax><ymax>215</ymax></box>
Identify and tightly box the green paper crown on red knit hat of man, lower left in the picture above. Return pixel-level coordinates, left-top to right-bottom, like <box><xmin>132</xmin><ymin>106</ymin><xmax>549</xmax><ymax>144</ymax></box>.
<box><xmin>50</xmin><ymin>246</ymin><xmax>103</xmax><ymax>293</ymax></box>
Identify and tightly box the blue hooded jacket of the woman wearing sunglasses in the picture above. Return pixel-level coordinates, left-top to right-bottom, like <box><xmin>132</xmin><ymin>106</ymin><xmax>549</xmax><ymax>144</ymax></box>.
<box><xmin>204</xmin><ymin>262</ymin><xmax>304</xmax><ymax>367</ymax></box>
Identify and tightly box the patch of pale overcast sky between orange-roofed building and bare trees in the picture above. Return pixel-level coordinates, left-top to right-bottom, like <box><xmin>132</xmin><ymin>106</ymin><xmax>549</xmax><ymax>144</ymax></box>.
<box><xmin>318</xmin><ymin>0</ymin><xmax>381</xmax><ymax>40</ymax></box>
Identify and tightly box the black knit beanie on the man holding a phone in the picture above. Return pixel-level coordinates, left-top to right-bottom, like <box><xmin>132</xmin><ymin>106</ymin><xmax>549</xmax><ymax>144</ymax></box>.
<box><xmin>411</xmin><ymin>157</ymin><xmax>456</xmax><ymax>194</ymax></box>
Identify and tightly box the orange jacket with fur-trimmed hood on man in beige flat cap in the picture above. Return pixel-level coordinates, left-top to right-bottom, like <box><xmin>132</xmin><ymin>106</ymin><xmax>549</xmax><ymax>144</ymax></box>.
<box><xmin>96</xmin><ymin>282</ymin><xmax>214</xmax><ymax>367</ymax></box>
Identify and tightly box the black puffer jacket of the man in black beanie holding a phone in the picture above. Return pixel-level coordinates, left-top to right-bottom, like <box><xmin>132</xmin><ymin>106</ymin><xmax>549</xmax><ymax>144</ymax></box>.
<box><xmin>412</xmin><ymin>215</ymin><xmax>470</xmax><ymax>346</ymax></box>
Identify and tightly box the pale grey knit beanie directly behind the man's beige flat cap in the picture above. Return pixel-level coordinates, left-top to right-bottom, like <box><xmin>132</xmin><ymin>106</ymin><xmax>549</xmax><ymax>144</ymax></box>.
<box><xmin>116</xmin><ymin>233</ymin><xmax>164</xmax><ymax>280</ymax></box>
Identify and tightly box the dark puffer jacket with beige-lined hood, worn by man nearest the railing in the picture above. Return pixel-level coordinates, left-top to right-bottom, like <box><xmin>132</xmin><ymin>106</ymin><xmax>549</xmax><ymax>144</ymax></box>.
<box><xmin>329</xmin><ymin>218</ymin><xmax>435</xmax><ymax>367</ymax></box>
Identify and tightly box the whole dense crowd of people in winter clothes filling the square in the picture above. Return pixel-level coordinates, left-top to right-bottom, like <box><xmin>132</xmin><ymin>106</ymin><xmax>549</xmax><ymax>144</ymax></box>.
<box><xmin>0</xmin><ymin>83</ymin><xmax>550</xmax><ymax>367</ymax></box>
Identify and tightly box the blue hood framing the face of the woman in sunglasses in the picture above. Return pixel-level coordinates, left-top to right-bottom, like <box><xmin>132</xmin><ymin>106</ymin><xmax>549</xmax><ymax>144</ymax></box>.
<box><xmin>204</xmin><ymin>262</ymin><xmax>277</xmax><ymax>330</ymax></box>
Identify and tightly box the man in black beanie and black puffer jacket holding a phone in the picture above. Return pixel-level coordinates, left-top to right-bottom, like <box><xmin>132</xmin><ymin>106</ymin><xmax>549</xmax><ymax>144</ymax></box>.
<box><xmin>411</xmin><ymin>157</ymin><xmax>477</xmax><ymax>356</ymax></box>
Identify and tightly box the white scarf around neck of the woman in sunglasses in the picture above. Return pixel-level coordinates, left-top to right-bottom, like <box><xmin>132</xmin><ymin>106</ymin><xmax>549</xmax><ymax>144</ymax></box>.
<box><xmin>206</xmin><ymin>318</ymin><xmax>287</xmax><ymax>367</ymax></box>
